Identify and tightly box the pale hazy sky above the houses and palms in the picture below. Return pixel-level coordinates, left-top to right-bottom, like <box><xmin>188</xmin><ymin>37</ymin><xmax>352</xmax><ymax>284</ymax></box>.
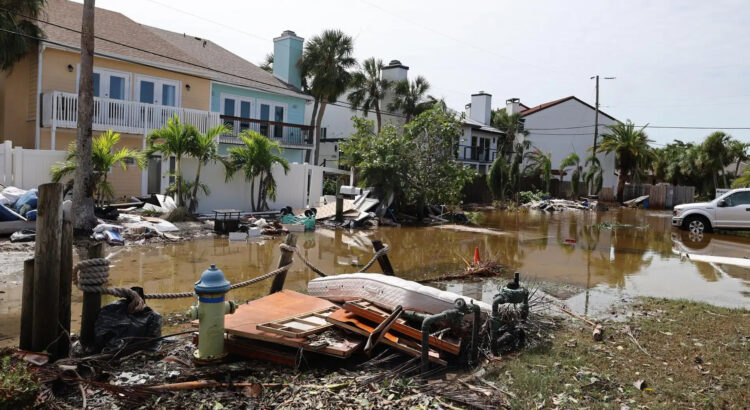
<box><xmin>89</xmin><ymin>0</ymin><xmax>750</xmax><ymax>144</ymax></box>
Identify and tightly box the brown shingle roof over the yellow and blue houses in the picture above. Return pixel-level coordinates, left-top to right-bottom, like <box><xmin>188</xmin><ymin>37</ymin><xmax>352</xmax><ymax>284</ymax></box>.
<box><xmin>40</xmin><ymin>0</ymin><xmax>310</xmax><ymax>98</ymax></box>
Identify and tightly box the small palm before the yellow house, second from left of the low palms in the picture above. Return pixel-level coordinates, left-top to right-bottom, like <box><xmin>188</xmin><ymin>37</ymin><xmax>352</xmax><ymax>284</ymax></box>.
<box><xmin>148</xmin><ymin>114</ymin><xmax>200</xmax><ymax>207</ymax></box>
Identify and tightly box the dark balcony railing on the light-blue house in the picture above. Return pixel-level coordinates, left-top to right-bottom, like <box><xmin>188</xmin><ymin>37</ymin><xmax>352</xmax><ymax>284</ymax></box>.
<box><xmin>219</xmin><ymin>115</ymin><xmax>314</xmax><ymax>148</ymax></box>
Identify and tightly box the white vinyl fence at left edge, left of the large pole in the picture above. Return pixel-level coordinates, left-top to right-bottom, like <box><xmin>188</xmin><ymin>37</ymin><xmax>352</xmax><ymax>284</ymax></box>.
<box><xmin>0</xmin><ymin>141</ymin><xmax>66</xmax><ymax>189</ymax></box>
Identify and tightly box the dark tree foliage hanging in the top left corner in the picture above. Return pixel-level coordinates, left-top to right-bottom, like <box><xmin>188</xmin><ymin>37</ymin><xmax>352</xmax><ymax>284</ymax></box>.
<box><xmin>0</xmin><ymin>0</ymin><xmax>47</xmax><ymax>71</ymax></box>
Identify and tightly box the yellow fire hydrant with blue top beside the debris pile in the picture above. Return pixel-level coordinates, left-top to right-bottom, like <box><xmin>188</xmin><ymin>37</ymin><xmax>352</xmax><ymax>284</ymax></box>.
<box><xmin>188</xmin><ymin>264</ymin><xmax>237</xmax><ymax>361</ymax></box>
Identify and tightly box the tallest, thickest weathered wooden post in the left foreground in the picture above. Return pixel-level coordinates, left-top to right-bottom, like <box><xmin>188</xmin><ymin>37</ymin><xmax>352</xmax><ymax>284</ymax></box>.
<box><xmin>31</xmin><ymin>183</ymin><xmax>63</xmax><ymax>352</ymax></box>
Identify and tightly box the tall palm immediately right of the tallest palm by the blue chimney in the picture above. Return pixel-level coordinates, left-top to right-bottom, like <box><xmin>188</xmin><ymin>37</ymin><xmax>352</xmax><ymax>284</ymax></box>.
<box><xmin>347</xmin><ymin>57</ymin><xmax>391</xmax><ymax>132</ymax></box>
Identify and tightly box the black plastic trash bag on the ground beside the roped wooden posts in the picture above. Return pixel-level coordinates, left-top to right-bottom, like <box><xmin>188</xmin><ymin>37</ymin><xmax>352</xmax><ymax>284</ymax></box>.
<box><xmin>94</xmin><ymin>299</ymin><xmax>162</xmax><ymax>352</ymax></box>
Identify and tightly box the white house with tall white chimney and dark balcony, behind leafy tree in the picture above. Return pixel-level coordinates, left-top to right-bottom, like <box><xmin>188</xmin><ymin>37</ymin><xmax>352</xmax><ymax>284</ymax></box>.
<box><xmin>457</xmin><ymin>91</ymin><xmax>505</xmax><ymax>175</ymax></box>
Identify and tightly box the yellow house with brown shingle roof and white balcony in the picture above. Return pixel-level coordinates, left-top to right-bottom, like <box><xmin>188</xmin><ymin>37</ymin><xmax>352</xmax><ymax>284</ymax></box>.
<box><xmin>0</xmin><ymin>0</ymin><xmax>309</xmax><ymax>197</ymax></box>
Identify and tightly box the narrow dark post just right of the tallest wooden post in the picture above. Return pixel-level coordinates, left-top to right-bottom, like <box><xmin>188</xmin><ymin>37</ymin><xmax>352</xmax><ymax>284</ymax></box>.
<box><xmin>57</xmin><ymin>220</ymin><xmax>73</xmax><ymax>358</ymax></box>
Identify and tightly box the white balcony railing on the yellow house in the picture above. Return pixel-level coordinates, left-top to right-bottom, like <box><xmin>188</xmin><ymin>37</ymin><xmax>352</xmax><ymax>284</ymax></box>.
<box><xmin>42</xmin><ymin>91</ymin><xmax>220</xmax><ymax>134</ymax></box>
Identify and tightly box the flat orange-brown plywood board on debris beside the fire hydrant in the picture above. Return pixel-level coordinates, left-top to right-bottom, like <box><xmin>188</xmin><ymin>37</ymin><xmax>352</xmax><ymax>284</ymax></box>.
<box><xmin>224</xmin><ymin>290</ymin><xmax>363</xmax><ymax>357</ymax></box>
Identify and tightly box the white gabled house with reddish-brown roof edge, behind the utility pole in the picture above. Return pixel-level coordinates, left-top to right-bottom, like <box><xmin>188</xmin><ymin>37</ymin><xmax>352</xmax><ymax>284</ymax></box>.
<box><xmin>505</xmin><ymin>96</ymin><xmax>619</xmax><ymax>187</ymax></box>
